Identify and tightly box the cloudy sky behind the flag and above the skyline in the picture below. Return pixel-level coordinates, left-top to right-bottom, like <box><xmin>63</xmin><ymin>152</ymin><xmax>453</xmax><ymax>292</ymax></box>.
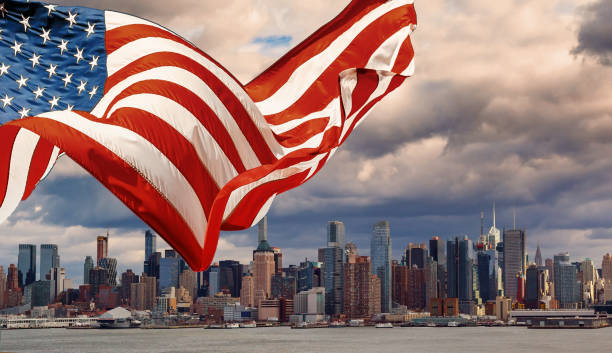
<box><xmin>0</xmin><ymin>0</ymin><xmax>612</xmax><ymax>283</ymax></box>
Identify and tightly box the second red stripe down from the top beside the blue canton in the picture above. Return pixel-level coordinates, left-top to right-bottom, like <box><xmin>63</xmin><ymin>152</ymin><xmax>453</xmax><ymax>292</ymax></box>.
<box><xmin>106</xmin><ymin>53</ymin><xmax>276</xmax><ymax>164</ymax></box>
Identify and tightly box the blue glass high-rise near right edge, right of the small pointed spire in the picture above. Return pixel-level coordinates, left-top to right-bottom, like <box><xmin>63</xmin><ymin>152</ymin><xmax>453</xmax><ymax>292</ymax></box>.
<box><xmin>554</xmin><ymin>253</ymin><xmax>580</xmax><ymax>309</ymax></box>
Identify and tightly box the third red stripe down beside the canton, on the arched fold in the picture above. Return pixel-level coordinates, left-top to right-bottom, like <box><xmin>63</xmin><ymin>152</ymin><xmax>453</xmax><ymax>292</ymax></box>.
<box><xmin>105</xmin><ymin>80</ymin><xmax>246</xmax><ymax>173</ymax></box>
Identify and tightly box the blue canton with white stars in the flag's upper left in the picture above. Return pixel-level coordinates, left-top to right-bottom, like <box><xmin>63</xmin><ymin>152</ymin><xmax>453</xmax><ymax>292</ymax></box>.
<box><xmin>0</xmin><ymin>0</ymin><xmax>107</xmax><ymax>123</ymax></box>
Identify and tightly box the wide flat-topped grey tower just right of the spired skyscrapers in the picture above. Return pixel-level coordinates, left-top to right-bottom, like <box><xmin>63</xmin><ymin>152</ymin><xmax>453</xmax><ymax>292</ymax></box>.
<box><xmin>503</xmin><ymin>229</ymin><xmax>526</xmax><ymax>298</ymax></box>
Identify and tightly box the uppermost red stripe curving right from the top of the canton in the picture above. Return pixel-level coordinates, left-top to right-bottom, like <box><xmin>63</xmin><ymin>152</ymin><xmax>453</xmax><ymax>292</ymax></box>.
<box><xmin>105</xmin><ymin>24</ymin><xmax>242</xmax><ymax>90</ymax></box>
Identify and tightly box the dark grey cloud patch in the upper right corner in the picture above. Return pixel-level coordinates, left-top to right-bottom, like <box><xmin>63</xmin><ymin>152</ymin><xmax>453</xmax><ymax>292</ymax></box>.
<box><xmin>572</xmin><ymin>0</ymin><xmax>612</xmax><ymax>65</ymax></box>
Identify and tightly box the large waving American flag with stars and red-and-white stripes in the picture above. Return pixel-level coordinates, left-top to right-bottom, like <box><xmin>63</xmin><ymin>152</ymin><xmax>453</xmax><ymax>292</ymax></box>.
<box><xmin>0</xmin><ymin>0</ymin><xmax>416</xmax><ymax>270</ymax></box>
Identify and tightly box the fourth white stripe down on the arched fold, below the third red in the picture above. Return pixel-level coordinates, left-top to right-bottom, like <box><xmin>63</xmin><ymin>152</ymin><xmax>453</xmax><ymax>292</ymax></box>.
<box><xmin>108</xmin><ymin>94</ymin><xmax>238</xmax><ymax>189</ymax></box>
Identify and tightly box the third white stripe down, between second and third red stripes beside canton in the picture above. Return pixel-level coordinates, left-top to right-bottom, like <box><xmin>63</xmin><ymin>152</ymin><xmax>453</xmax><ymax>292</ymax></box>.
<box><xmin>94</xmin><ymin>66</ymin><xmax>261</xmax><ymax>169</ymax></box>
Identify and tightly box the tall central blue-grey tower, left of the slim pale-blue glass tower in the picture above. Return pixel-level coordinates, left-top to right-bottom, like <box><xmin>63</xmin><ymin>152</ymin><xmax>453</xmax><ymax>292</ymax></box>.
<box><xmin>324</xmin><ymin>221</ymin><xmax>345</xmax><ymax>315</ymax></box>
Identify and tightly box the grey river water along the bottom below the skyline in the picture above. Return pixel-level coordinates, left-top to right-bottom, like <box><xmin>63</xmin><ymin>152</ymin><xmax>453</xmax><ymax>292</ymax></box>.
<box><xmin>0</xmin><ymin>327</ymin><xmax>612</xmax><ymax>353</ymax></box>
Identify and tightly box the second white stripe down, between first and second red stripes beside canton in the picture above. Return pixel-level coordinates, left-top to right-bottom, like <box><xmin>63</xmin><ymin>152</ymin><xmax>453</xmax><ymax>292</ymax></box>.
<box><xmin>101</xmin><ymin>38</ymin><xmax>283</xmax><ymax>157</ymax></box>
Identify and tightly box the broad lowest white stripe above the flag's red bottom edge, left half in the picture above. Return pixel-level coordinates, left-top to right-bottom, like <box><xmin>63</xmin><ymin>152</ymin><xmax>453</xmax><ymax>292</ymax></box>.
<box><xmin>40</xmin><ymin>111</ymin><xmax>207</xmax><ymax>246</ymax></box>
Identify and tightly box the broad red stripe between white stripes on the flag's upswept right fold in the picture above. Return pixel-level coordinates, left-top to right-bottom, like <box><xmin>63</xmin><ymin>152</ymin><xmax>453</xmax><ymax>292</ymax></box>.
<box><xmin>253</xmin><ymin>7</ymin><xmax>416</xmax><ymax>125</ymax></box>
